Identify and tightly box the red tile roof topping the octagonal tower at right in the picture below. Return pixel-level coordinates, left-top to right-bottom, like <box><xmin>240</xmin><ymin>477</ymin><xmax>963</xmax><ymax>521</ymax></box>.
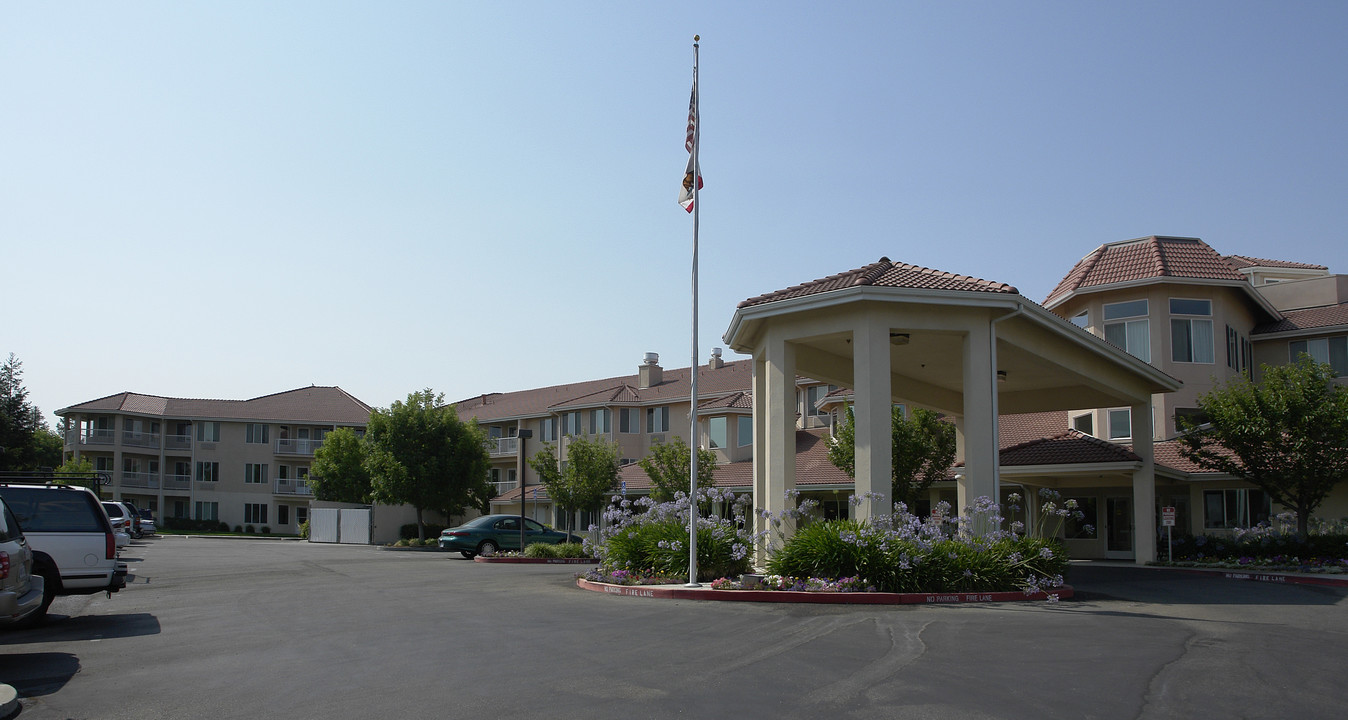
<box><xmin>1043</xmin><ymin>236</ymin><xmax>1247</xmax><ymax>307</ymax></box>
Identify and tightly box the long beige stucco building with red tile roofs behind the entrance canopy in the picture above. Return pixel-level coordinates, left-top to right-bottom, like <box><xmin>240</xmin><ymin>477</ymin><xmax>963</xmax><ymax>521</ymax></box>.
<box><xmin>474</xmin><ymin>236</ymin><xmax>1348</xmax><ymax>558</ymax></box>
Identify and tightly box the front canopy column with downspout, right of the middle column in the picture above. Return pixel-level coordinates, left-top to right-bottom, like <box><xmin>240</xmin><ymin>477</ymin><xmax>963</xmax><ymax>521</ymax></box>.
<box><xmin>956</xmin><ymin>324</ymin><xmax>998</xmax><ymax>514</ymax></box>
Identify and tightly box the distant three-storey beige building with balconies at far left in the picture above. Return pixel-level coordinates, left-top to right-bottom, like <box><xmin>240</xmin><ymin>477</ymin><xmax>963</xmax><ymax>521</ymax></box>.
<box><xmin>57</xmin><ymin>386</ymin><xmax>371</xmax><ymax>534</ymax></box>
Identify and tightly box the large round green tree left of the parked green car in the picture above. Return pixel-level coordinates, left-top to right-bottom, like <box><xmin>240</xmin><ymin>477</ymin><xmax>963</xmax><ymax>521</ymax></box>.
<box><xmin>365</xmin><ymin>388</ymin><xmax>492</xmax><ymax>539</ymax></box>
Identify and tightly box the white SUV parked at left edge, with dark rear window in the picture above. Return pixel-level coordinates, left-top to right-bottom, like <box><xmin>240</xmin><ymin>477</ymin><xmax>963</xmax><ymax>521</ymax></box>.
<box><xmin>0</xmin><ymin>481</ymin><xmax>127</xmax><ymax>618</ymax></box>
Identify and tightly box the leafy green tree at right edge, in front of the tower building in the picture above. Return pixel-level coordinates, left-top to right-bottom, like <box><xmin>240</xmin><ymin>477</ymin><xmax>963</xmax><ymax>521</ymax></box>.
<box><xmin>1178</xmin><ymin>355</ymin><xmax>1348</xmax><ymax>538</ymax></box>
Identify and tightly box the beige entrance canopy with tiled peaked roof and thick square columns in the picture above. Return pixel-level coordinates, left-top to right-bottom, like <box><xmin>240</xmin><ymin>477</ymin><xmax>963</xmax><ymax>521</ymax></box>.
<box><xmin>725</xmin><ymin>258</ymin><xmax>1180</xmax><ymax>562</ymax></box>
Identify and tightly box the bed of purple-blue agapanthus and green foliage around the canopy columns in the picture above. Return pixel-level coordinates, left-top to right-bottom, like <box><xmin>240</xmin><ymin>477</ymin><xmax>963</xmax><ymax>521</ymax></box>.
<box><xmin>582</xmin><ymin>489</ymin><xmax>1078</xmax><ymax>596</ymax></box>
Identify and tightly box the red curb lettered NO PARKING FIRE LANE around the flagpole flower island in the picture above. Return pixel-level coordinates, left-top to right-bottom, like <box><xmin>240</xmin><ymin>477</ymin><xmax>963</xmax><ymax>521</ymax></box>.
<box><xmin>576</xmin><ymin>577</ymin><xmax>1073</xmax><ymax>605</ymax></box>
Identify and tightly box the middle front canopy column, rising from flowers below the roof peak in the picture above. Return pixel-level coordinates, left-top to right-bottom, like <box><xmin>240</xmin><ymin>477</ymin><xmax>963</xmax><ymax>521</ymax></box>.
<box><xmin>852</xmin><ymin>314</ymin><xmax>894</xmax><ymax>520</ymax></box>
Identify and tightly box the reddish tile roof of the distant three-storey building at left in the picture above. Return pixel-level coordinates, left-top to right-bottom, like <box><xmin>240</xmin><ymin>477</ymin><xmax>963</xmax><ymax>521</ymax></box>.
<box><xmin>57</xmin><ymin>386</ymin><xmax>371</xmax><ymax>425</ymax></box>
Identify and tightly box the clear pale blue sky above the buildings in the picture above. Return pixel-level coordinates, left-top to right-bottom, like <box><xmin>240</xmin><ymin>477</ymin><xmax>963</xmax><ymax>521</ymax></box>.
<box><xmin>0</xmin><ymin>0</ymin><xmax>1348</xmax><ymax>419</ymax></box>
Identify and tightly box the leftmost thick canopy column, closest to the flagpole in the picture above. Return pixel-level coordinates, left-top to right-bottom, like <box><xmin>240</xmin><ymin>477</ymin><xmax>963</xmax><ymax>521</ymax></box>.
<box><xmin>755</xmin><ymin>334</ymin><xmax>795</xmax><ymax>560</ymax></box>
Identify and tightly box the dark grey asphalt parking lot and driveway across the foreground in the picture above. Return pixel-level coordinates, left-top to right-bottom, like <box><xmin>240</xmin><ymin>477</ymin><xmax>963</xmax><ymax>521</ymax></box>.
<box><xmin>0</xmin><ymin>538</ymin><xmax>1348</xmax><ymax>720</ymax></box>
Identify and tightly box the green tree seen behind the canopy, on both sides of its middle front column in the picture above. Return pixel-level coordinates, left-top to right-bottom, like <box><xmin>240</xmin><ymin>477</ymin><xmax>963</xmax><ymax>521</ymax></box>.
<box><xmin>829</xmin><ymin>406</ymin><xmax>956</xmax><ymax>508</ymax></box>
